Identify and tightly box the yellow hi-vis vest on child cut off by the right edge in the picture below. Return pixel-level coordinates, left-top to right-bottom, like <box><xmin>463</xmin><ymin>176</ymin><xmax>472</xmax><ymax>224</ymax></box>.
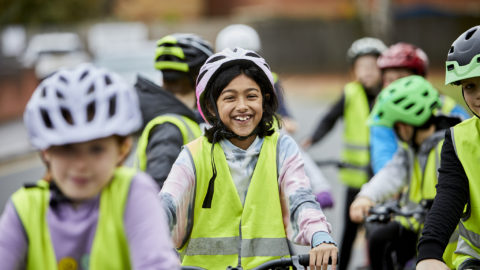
<box><xmin>451</xmin><ymin>117</ymin><xmax>480</xmax><ymax>259</ymax></box>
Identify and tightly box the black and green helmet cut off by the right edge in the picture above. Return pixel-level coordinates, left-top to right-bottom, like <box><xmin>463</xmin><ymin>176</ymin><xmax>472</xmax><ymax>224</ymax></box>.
<box><xmin>445</xmin><ymin>25</ymin><xmax>480</xmax><ymax>84</ymax></box>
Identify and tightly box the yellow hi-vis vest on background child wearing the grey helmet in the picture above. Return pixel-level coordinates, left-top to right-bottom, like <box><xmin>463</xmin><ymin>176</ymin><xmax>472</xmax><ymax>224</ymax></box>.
<box><xmin>339</xmin><ymin>82</ymin><xmax>370</xmax><ymax>188</ymax></box>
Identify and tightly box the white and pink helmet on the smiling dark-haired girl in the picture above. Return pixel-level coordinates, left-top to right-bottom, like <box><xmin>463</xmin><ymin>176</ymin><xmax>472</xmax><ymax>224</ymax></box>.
<box><xmin>196</xmin><ymin>48</ymin><xmax>274</xmax><ymax>122</ymax></box>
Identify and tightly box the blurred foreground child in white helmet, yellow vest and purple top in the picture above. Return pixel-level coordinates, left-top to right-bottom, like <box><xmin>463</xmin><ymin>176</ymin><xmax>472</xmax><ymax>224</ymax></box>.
<box><xmin>0</xmin><ymin>65</ymin><xmax>179</xmax><ymax>270</ymax></box>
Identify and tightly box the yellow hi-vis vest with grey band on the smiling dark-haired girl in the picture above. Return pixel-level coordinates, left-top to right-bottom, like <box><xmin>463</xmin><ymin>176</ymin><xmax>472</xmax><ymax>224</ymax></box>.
<box><xmin>180</xmin><ymin>132</ymin><xmax>290</xmax><ymax>270</ymax></box>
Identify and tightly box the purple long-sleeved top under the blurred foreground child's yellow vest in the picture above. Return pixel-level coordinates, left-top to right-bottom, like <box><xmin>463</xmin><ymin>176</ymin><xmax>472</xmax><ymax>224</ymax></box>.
<box><xmin>0</xmin><ymin>173</ymin><xmax>180</xmax><ymax>269</ymax></box>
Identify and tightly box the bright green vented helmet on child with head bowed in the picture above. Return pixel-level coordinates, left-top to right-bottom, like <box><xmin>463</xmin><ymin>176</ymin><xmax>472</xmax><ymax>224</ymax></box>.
<box><xmin>367</xmin><ymin>75</ymin><xmax>441</xmax><ymax>127</ymax></box>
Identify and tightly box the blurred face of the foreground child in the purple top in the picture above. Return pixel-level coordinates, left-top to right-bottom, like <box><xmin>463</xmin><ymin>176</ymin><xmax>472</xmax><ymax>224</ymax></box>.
<box><xmin>42</xmin><ymin>136</ymin><xmax>132</xmax><ymax>202</ymax></box>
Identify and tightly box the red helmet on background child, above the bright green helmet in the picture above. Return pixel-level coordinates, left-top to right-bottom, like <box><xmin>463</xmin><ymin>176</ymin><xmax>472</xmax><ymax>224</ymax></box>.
<box><xmin>377</xmin><ymin>42</ymin><xmax>428</xmax><ymax>76</ymax></box>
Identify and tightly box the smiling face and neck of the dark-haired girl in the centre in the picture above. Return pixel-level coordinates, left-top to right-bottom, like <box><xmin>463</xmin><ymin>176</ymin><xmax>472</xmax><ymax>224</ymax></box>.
<box><xmin>217</xmin><ymin>74</ymin><xmax>263</xmax><ymax>149</ymax></box>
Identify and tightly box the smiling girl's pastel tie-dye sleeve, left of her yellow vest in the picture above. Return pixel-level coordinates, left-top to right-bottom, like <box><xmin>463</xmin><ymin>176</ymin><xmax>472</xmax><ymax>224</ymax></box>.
<box><xmin>159</xmin><ymin>148</ymin><xmax>195</xmax><ymax>248</ymax></box>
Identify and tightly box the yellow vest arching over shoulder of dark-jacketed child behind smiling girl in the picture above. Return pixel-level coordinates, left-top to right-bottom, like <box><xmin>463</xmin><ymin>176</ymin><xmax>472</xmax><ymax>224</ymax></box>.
<box><xmin>135</xmin><ymin>114</ymin><xmax>202</xmax><ymax>171</ymax></box>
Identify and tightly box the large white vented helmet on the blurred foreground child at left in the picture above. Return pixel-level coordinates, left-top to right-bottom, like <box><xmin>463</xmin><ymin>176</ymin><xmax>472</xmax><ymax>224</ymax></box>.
<box><xmin>23</xmin><ymin>64</ymin><xmax>142</xmax><ymax>149</ymax></box>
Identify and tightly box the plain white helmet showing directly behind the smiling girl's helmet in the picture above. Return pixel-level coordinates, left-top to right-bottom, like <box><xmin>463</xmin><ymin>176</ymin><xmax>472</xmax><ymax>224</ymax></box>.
<box><xmin>215</xmin><ymin>24</ymin><xmax>262</xmax><ymax>52</ymax></box>
